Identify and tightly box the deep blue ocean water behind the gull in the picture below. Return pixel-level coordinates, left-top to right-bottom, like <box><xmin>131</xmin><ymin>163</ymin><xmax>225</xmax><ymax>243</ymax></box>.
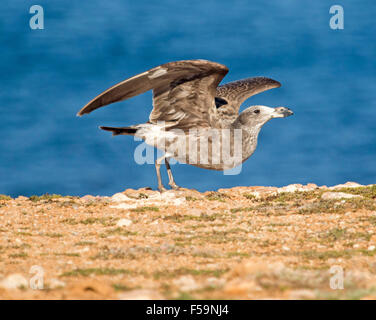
<box><xmin>0</xmin><ymin>0</ymin><xmax>376</xmax><ymax>196</ymax></box>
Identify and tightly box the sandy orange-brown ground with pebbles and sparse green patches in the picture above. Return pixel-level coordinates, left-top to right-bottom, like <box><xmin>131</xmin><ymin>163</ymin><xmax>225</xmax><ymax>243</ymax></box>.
<box><xmin>0</xmin><ymin>183</ymin><xmax>376</xmax><ymax>299</ymax></box>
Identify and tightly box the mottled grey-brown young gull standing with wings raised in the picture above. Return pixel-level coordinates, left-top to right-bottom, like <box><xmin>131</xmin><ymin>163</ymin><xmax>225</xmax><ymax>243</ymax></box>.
<box><xmin>77</xmin><ymin>60</ymin><xmax>293</xmax><ymax>191</ymax></box>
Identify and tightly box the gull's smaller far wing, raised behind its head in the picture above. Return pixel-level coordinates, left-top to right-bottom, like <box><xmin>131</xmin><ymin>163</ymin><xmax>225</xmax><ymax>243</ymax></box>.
<box><xmin>215</xmin><ymin>77</ymin><xmax>281</xmax><ymax>115</ymax></box>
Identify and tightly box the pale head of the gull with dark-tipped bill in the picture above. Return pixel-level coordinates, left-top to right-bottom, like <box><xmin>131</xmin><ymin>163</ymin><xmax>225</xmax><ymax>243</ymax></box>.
<box><xmin>238</xmin><ymin>106</ymin><xmax>294</xmax><ymax>127</ymax></box>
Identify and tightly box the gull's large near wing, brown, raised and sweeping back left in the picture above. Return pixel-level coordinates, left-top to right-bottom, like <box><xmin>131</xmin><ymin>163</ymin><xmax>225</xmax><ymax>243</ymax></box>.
<box><xmin>78</xmin><ymin>60</ymin><xmax>228</xmax><ymax>129</ymax></box>
